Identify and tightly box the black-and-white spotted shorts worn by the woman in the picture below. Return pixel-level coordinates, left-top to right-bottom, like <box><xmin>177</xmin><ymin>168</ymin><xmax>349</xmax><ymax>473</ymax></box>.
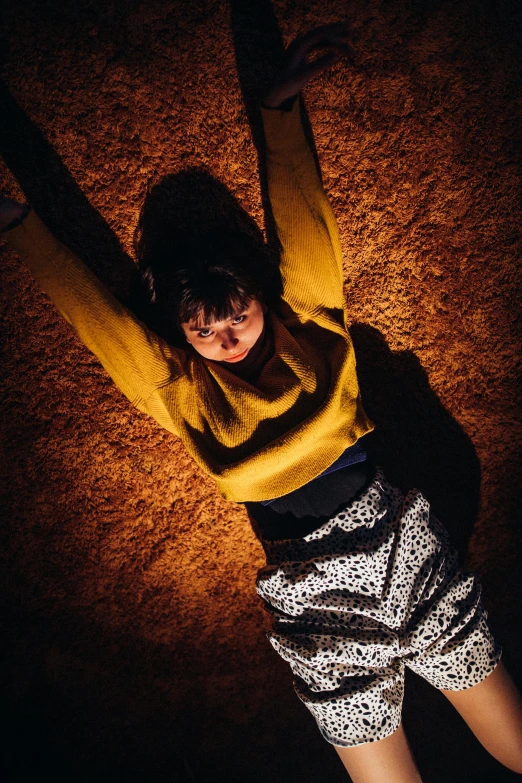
<box><xmin>257</xmin><ymin>469</ymin><xmax>501</xmax><ymax>747</ymax></box>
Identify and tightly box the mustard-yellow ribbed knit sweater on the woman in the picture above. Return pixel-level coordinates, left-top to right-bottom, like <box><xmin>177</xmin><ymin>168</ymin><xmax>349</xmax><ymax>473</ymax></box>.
<box><xmin>5</xmin><ymin>101</ymin><xmax>372</xmax><ymax>502</ymax></box>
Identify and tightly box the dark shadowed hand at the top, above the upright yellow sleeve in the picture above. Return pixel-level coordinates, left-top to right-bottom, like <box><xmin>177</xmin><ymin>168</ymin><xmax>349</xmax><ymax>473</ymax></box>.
<box><xmin>263</xmin><ymin>22</ymin><xmax>354</xmax><ymax>109</ymax></box>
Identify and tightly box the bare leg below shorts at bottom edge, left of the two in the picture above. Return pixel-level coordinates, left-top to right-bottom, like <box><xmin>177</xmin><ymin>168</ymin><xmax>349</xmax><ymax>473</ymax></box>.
<box><xmin>335</xmin><ymin>723</ymin><xmax>422</xmax><ymax>783</ymax></box>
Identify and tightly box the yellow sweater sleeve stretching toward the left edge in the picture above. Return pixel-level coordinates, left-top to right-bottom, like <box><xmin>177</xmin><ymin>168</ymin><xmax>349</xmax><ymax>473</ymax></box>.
<box><xmin>3</xmin><ymin>211</ymin><xmax>181</xmax><ymax>408</ymax></box>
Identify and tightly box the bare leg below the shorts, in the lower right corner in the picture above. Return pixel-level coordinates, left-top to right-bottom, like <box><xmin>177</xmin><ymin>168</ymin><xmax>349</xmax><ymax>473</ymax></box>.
<box><xmin>442</xmin><ymin>663</ymin><xmax>522</xmax><ymax>774</ymax></box>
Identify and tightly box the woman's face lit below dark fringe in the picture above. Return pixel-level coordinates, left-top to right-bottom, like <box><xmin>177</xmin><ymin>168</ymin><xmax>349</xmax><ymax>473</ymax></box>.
<box><xmin>181</xmin><ymin>299</ymin><xmax>267</xmax><ymax>364</ymax></box>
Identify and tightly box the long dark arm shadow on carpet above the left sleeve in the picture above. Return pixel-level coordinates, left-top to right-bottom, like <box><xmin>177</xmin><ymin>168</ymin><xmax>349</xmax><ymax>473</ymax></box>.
<box><xmin>0</xmin><ymin>80</ymin><xmax>136</xmax><ymax>304</ymax></box>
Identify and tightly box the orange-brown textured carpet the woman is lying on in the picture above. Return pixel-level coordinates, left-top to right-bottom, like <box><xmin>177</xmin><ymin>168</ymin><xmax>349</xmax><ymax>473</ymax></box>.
<box><xmin>0</xmin><ymin>0</ymin><xmax>522</xmax><ymax>783</ymax></box>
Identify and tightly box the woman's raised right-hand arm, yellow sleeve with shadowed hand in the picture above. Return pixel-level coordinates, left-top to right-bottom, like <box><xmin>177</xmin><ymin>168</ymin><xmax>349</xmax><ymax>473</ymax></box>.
<box><xmin>262</xmin><ymin>24</ymin><xmax>352</xmax><ymax>315</ymax></box>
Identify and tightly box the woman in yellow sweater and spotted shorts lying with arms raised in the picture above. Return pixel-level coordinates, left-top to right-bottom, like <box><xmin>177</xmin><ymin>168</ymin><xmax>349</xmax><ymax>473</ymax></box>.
<box><xmin>0</xmin><ymin>25</ymin><xmax>522</xmax><ymax>783</ymax></box>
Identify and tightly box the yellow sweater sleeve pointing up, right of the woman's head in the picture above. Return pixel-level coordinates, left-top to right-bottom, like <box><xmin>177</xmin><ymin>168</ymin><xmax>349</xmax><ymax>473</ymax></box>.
<box><xmin>261</xmin><ymin>100</ymin><xmax>345</xmax><ymax>314</ymax></box>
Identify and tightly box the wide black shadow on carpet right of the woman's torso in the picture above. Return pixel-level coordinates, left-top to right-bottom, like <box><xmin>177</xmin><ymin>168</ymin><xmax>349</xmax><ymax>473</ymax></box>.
<box><xmin>350</xmin><ymin>323</ymin><xmax>480</xmax><ymax>558</ymax></box>
